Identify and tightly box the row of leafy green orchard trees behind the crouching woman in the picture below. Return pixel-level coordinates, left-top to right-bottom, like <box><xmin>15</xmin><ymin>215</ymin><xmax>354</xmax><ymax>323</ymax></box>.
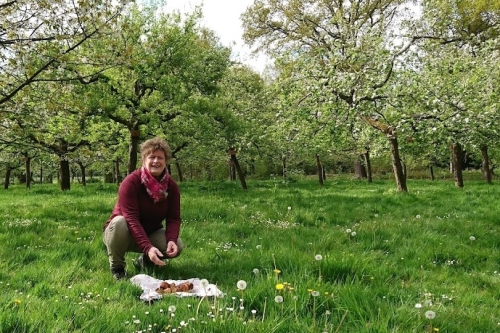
<box><xmin>0</xmin><ymin>0</ymin><xmax>500</xmax><ymax>191</ymax></box>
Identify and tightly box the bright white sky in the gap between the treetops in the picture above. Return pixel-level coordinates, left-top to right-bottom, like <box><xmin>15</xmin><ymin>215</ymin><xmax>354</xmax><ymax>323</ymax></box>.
<box><xmin>166</xmin><ymin>0</ymin><xmax>268</xmax><ymax>73</ymax></box>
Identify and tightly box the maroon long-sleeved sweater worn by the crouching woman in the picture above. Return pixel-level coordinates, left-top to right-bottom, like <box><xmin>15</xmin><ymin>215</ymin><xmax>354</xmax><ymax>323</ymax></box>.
<box><xmin>103</xmin><ymin>170</ymin><xmax>181</xmax><ymax>254</ymax></box>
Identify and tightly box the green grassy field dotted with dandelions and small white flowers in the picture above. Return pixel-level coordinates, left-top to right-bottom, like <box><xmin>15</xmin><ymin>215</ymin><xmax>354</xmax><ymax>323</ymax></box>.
<box><xmin>0</xmin><ymin>178</ymin><xmax>500</xmax><ymax>333</ymax></box>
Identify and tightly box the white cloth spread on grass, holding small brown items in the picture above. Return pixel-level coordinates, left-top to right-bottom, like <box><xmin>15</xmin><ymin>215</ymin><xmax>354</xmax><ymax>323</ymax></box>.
<box><xmin>130</xmin><ymin>274</ymin><xmax>224</xmax><ymax>302</ymax></box>
